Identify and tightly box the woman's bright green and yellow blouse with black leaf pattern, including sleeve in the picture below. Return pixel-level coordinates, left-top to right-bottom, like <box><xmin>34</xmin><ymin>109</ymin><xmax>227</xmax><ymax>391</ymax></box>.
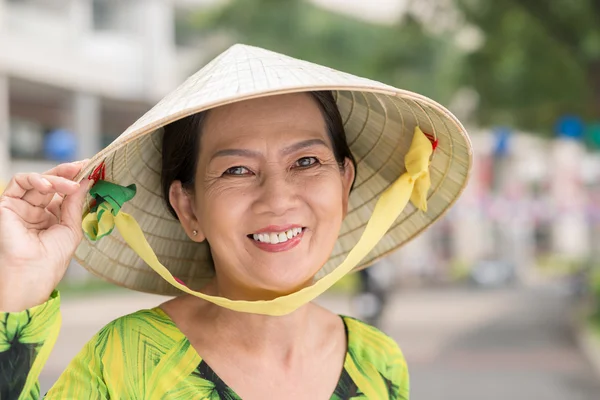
<box><xmin>0</xmin><ymin>292</ymin><xmax>409</xmax><ymax>400</ymax></box>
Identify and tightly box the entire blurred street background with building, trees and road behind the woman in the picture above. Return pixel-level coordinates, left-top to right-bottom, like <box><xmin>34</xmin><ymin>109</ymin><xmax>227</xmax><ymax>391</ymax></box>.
<box><xmin>0</xmin><ymin>0</ymin><xmax>600</xmax><ymax>400</ymax></box>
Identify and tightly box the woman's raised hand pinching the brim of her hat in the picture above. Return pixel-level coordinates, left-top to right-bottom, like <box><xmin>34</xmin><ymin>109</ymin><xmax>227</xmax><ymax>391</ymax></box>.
<box><xmin>0</xmin><ymin>161</ymin><xmax>91</xmax><ymax>312</ymax></box>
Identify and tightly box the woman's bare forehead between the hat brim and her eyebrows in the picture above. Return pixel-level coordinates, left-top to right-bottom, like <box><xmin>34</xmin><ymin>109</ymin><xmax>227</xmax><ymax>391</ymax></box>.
<box><xmin>202</xmin><ymin>93</ymin><xmax>326</xmax><ymax>144</ymax></box>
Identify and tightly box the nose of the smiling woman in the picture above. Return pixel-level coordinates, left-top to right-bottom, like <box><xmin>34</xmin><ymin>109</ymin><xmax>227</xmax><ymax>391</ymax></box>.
<box><xmin>253</xmin><ymin>172</ymin><xmax>301</xmax><ymax>216</ymax></box>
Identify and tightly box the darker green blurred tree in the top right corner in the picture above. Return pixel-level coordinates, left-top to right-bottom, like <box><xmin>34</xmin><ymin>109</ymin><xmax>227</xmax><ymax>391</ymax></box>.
<box><xmin>434</xmin><ymin>0</ymin><xmax>600</xmax><ymax>135</ymax></box>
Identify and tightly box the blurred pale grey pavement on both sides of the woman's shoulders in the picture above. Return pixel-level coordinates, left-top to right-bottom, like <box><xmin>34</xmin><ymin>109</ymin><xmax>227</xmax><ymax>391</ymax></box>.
<box><xmin>41</xmin><ymin>282</ymin><xmax>600</xmax><ymax>400</ymax></box>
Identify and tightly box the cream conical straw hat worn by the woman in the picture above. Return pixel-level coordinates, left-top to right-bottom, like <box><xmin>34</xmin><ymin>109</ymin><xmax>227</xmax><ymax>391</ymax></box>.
<box><xmin>75</xmin><ymin>45</ymin><xmax>472</xmax><ymax>295</ymax></box>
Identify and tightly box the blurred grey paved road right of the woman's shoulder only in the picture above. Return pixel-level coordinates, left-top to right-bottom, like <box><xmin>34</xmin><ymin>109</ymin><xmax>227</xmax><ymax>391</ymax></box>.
<box><xmin>385</xmin><ymin>288</ymin><xmax>600</xmax><ymax>400</ymax></box>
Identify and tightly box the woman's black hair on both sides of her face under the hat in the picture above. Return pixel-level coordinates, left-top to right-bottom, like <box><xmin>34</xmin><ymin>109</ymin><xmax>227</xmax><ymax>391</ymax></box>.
<box><xmin>161</xmin><ymin>91</ymin><xmax>356</xmax><ymax>218</ymax></box>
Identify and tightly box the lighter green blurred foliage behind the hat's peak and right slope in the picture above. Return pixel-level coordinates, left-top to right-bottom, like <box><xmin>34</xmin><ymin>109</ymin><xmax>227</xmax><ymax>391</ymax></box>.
<box><xmin>181</xmin><ymin>0</ymin><xmax>461</xmax><ymax>102</ymax></box>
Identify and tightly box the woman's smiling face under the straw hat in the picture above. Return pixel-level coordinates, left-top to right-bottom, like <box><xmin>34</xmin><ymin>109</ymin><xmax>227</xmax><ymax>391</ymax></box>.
<box><xmin>180</xmin><ymin>94</ymin><xmax>354</xmax><ymax>299</ymax></box>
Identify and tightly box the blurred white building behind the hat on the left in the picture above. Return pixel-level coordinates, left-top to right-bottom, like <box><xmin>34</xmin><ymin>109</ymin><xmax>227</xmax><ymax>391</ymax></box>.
<box><xmin>0</xmin><ymin>0</ymin><xmax>214</xmax><ymax>180</ymax></box>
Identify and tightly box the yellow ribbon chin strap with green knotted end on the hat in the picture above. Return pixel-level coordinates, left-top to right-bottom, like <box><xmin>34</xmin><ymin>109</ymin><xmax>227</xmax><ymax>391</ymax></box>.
<box><xmin>82</xmin><ymin>127</ymin><xmax>434</xmax><ymax>316</ymax></box>
